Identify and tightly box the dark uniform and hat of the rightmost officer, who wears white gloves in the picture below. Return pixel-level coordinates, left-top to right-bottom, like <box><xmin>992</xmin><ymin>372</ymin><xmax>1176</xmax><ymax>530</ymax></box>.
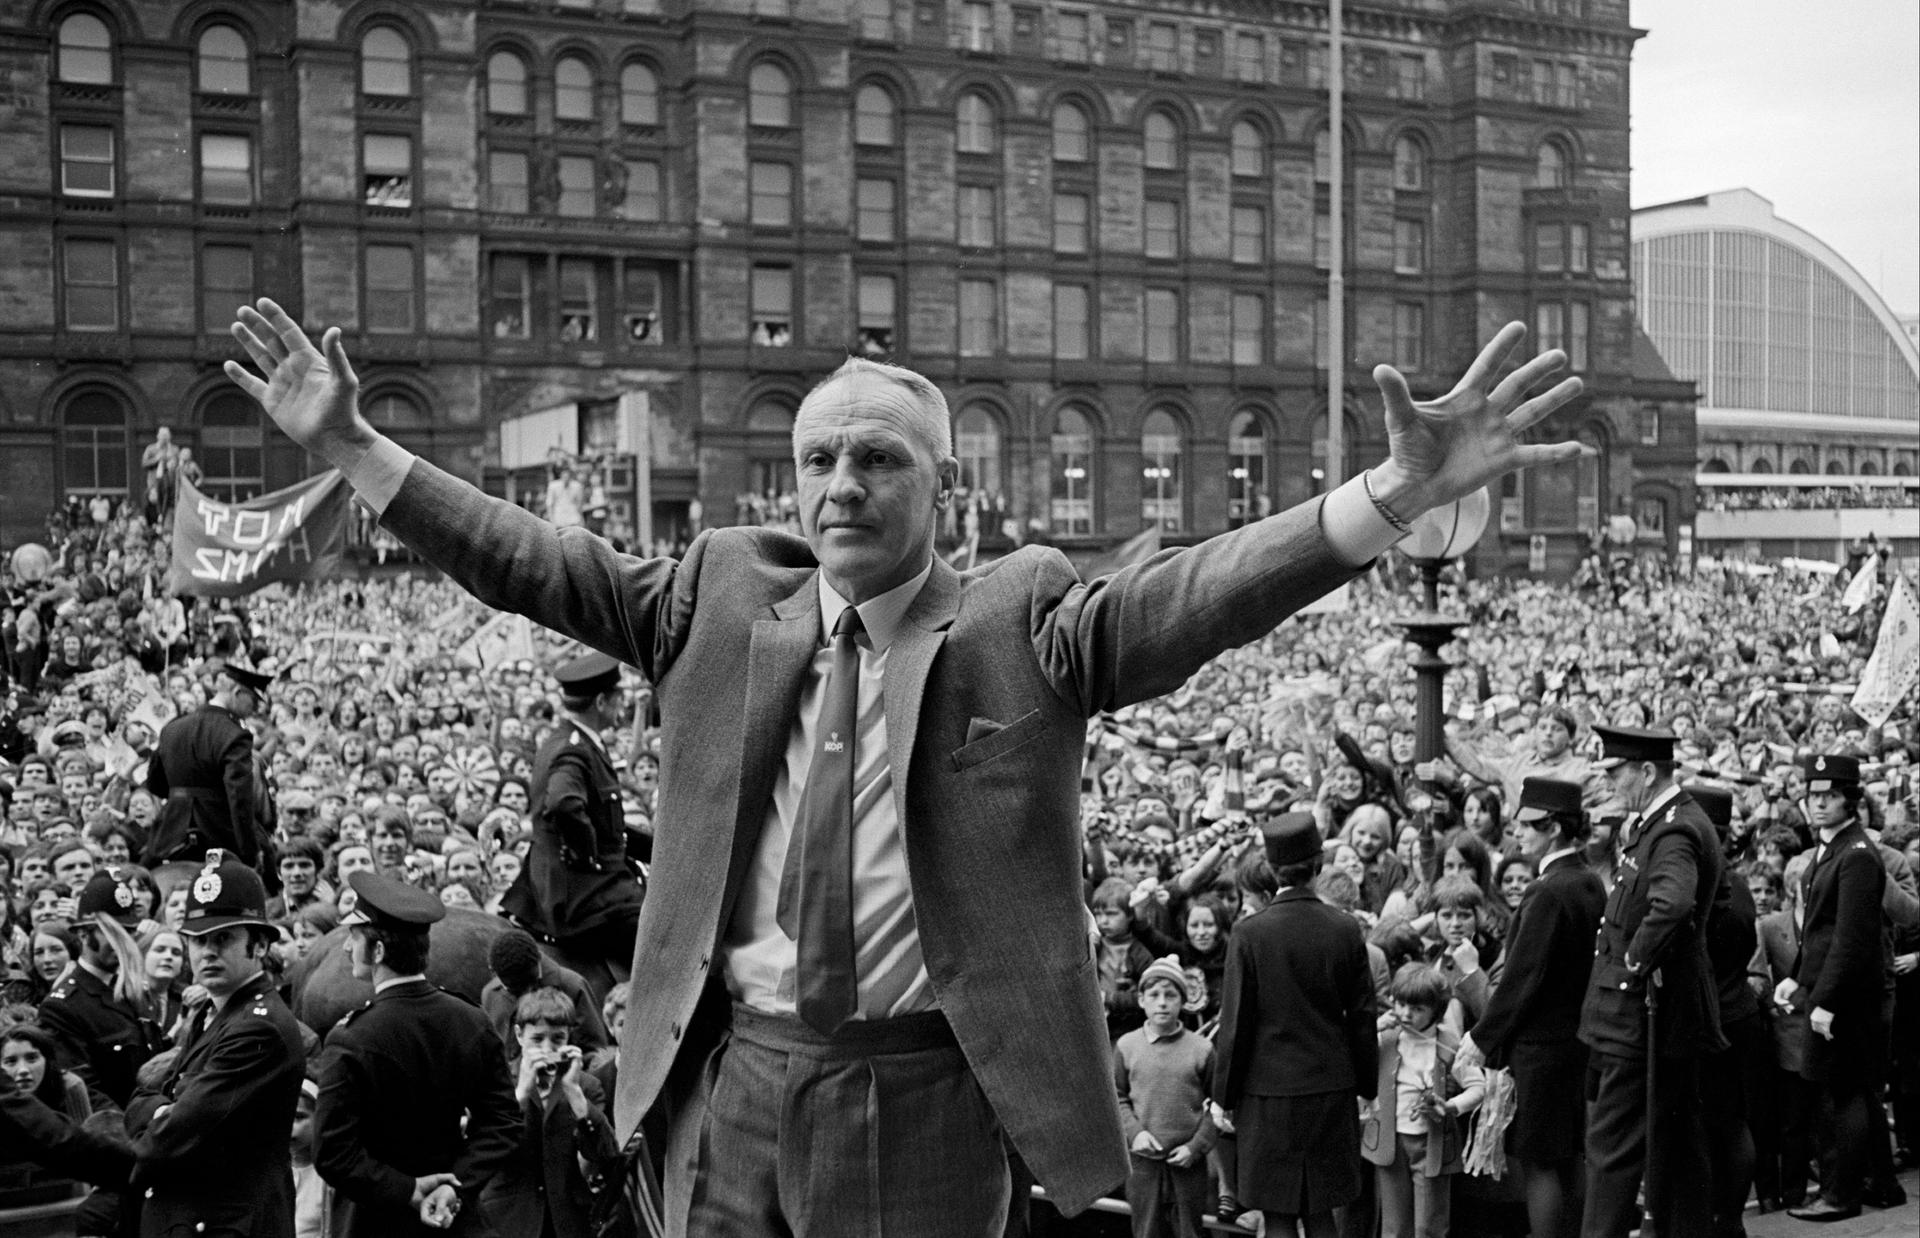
<box><xmin>1789</xmin><ymin>756</ymin><xmax>1893</xmax><ymax>1221</ymax></box>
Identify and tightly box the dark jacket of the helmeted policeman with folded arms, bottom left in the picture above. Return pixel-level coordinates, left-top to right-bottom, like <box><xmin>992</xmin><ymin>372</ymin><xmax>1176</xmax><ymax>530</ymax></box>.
<box><xmin>127</xmin><ymin>973</ymin><xmax>305</xmax><ymax>1238</ymax></box>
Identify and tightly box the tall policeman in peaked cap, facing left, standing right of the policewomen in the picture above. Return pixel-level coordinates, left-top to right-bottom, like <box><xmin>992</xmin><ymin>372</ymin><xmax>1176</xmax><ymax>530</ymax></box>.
<box><xmin>1580</xmin><ymin>726</ymin><xmax>1726</xmax><ymax>1238</ymax></box>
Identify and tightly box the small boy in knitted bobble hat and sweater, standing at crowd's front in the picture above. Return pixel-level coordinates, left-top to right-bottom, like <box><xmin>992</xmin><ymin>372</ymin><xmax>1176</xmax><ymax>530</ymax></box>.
<box><xmin>1114</xmin><ymin>956</ymin><xmax>1215</xmax><ymax>1238</ymax></box>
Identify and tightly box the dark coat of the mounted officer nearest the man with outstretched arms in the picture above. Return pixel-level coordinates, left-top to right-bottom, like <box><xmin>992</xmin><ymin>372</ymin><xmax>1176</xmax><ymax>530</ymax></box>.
<box><xmin>501</xmin><ymin>720</ymin><xmax>641</xmax><ymax>940</ymax></box>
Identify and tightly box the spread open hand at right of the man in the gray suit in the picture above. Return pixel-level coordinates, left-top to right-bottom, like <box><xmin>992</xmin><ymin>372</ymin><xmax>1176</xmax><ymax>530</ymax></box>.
<box><xmin>1373</xmin><ymin>322</ymin><xmax>1594</xmax><ymax>520</ymax></box>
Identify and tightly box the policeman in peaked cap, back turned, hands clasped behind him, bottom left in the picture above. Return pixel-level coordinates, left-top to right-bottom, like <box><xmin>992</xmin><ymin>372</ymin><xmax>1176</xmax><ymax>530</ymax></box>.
<box><xmin>316</xmin><ymin>871</ymin><xmax>520</xmax><ymax>1238</ymax></box>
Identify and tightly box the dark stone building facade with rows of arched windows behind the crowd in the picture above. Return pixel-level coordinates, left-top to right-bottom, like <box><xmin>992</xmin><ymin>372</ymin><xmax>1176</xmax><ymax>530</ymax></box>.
<box><xmin>0</xmin><ymin>0</ymin><xmax>1693</xmax><ymax>570</ymax></box>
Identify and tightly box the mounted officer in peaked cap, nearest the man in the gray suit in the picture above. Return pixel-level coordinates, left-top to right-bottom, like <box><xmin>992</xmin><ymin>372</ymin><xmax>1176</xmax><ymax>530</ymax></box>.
<box><xmin>501</xmin><ymin>653</ymin><xmax>641</xmax><ymax>967</ymax></box>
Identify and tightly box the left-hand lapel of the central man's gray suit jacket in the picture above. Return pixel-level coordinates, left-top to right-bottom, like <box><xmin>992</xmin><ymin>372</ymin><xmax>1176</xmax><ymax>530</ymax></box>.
<box><xmin>720</xmin><ymin>574</ymin><xmax>820</xmax><ymax>925</ymax></box>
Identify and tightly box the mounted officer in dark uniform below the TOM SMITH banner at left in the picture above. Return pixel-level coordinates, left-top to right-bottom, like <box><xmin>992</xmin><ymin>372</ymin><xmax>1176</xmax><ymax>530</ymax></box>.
<box><xmin>140</xmin><ymin>662</ymin><xmax>273</xmax><ymax>869</ymax></box>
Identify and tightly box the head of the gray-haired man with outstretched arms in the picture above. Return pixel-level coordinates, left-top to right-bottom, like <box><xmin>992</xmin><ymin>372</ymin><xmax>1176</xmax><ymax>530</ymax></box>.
<box><xmin>793</xmin><ymin>374</ymin><xmax>960</xmax><ymax>603</ymax></box>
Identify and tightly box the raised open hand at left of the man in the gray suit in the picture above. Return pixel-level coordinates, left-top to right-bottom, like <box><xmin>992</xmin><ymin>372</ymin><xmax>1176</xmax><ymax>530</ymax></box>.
<box><xmin>225</xmin><ymin>298</ymin><xmax>376</xmax><ymax>470</ymax></box>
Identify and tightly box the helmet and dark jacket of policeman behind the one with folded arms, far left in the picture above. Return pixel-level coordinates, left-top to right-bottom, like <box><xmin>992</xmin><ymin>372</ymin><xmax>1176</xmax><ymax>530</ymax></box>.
<box><xmin>40</xmin><ymin>868</ymin><xmax>167</xmax><ymax>1107</ymax></box>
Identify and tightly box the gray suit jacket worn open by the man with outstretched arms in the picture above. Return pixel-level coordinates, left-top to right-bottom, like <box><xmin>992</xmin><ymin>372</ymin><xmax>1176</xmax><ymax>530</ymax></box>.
<box><xmin>382</xmin><ymin>463</ymin><xmax>1354</xmax><ymax>1213</ymax></box>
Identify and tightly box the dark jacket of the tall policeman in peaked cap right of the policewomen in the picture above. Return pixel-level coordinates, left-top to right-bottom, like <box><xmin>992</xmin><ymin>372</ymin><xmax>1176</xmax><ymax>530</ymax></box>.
<box><xmin>1580</xmin><ymin>791</ymin><xmax>1726</xmax><ymax>1058</ymax></box>
